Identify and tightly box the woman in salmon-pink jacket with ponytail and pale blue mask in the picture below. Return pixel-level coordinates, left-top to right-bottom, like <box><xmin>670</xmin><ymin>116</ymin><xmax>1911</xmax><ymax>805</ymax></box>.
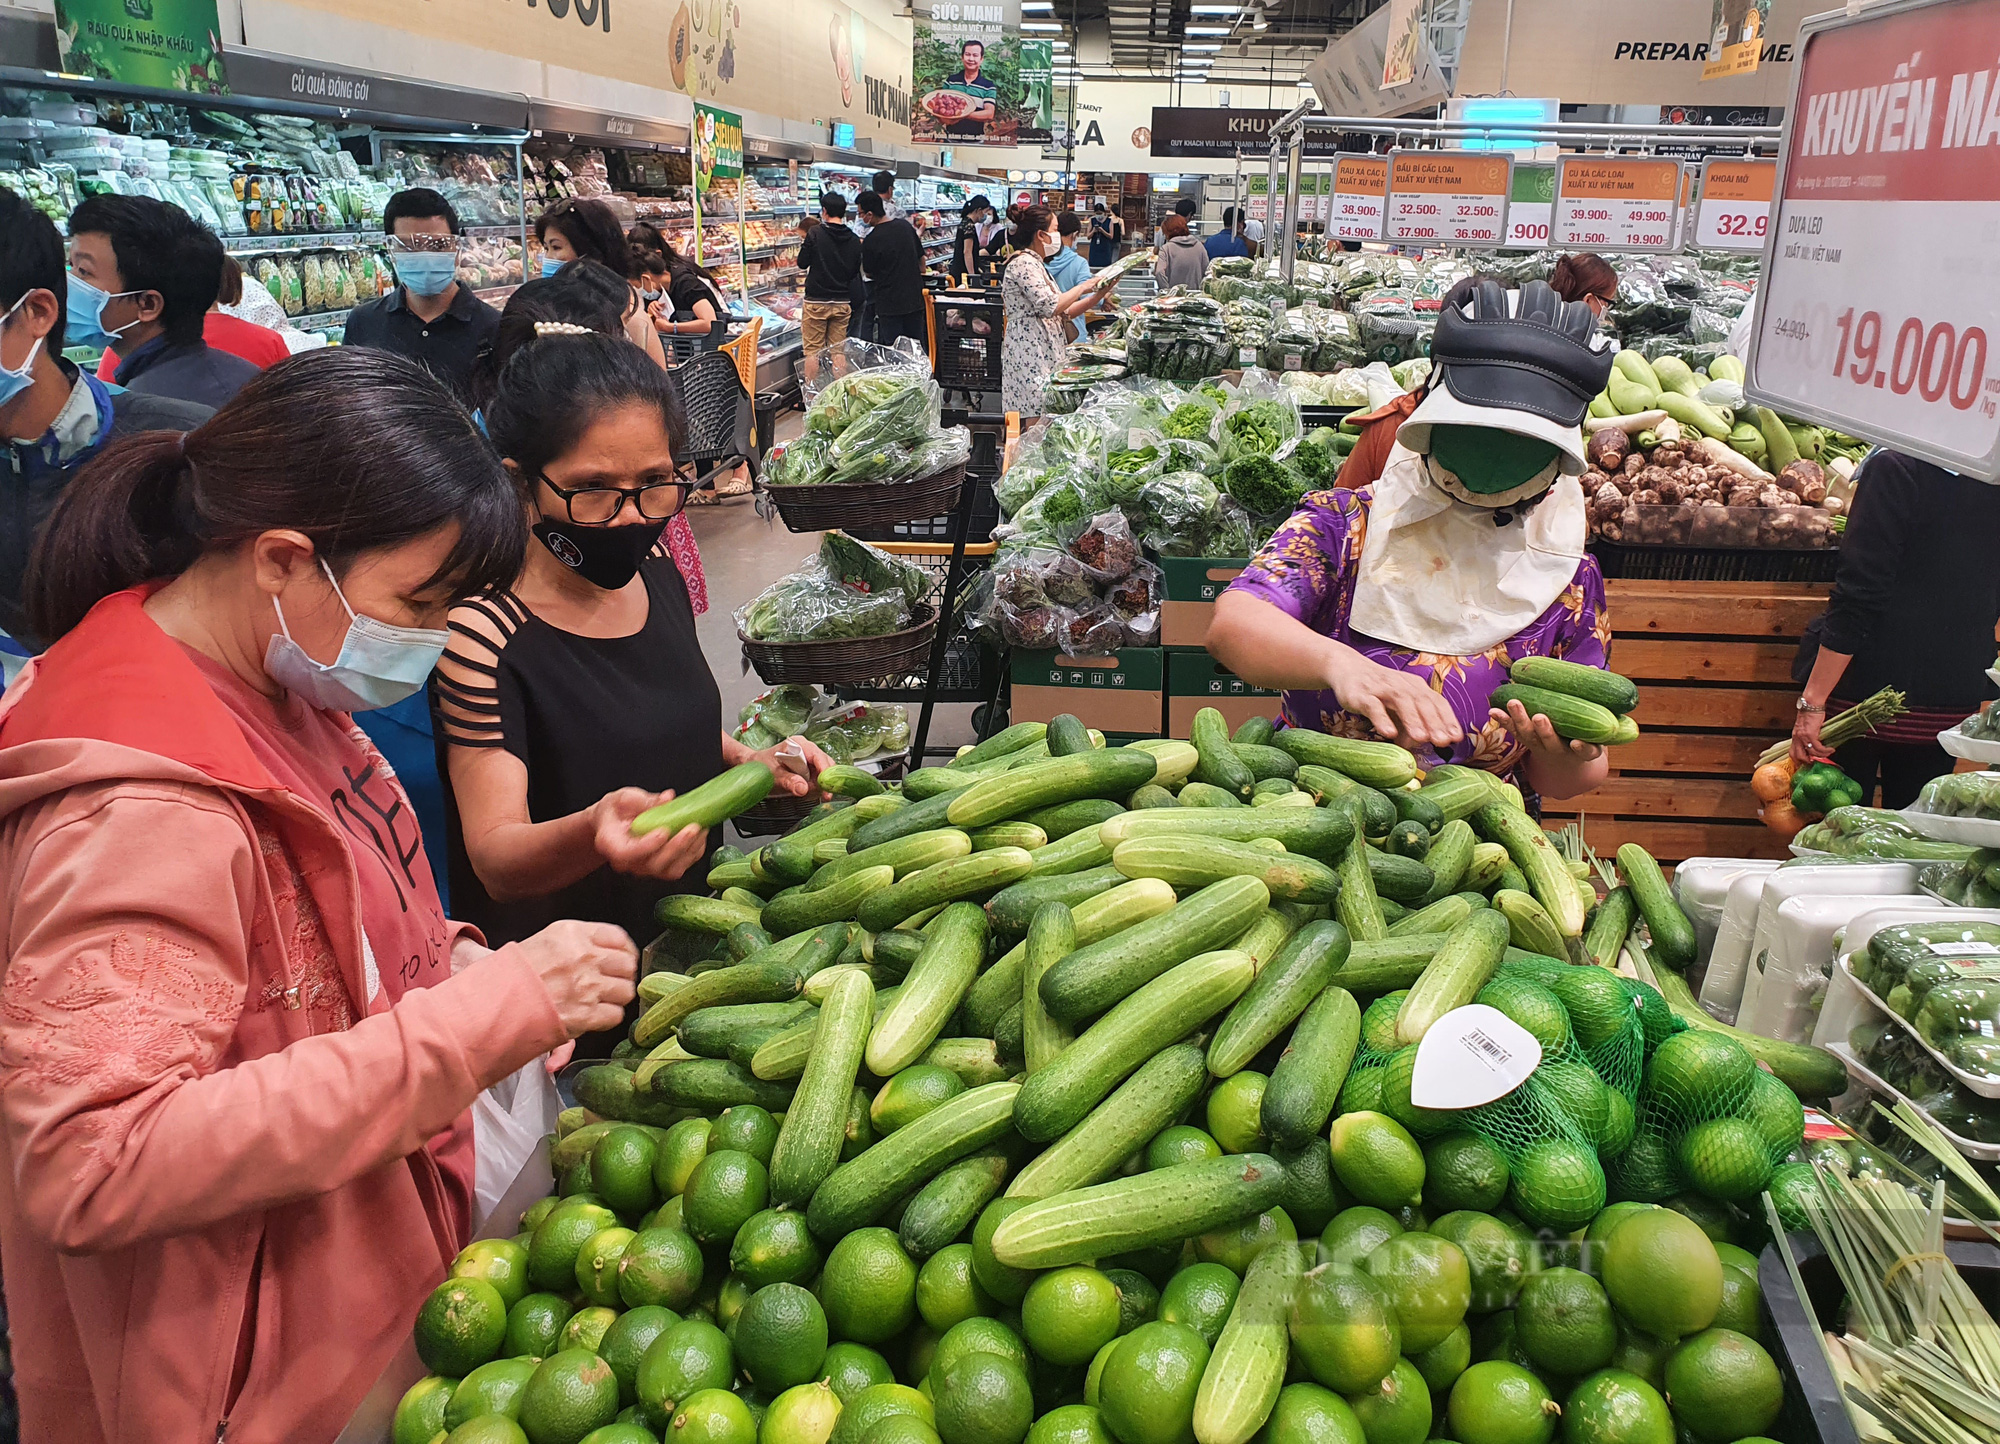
<box><xmin>0</xmin><ymin>348</ymin><xmax>636</xmax><ymax>1444</ymax></box>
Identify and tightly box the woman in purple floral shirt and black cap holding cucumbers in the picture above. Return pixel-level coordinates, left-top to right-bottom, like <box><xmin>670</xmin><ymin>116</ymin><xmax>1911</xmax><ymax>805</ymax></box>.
<box><xmin>1208</xmin><ymin>282</ymin><xmax>1610</xmax><ymax>798</ymax></box>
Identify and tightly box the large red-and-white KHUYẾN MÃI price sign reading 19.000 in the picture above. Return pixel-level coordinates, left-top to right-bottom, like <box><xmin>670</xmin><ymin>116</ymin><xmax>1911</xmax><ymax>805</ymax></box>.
<box><xmin>1748</xmin><ymin>0</ymin><xmax>2000</xmax><ymax>482</ymax></box>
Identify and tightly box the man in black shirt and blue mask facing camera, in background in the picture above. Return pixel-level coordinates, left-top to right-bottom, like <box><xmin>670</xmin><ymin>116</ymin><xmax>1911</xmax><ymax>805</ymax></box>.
<box><xmin>344</xmin><ymin>186</ymin><xmax>500</xmax><ymax>400</ymax></box>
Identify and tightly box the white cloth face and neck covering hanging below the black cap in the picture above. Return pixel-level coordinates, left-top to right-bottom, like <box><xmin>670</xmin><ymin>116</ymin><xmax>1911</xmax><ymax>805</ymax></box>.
<box><xmin>1350</xmin><ymin>444</ymin><xmax>1584</xmax><ymax>656</ymax></box>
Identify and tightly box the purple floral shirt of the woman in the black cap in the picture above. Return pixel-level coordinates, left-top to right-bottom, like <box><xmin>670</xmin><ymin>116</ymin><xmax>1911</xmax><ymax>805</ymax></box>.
<box><xmin>1230</xmin><ymin>488</ymin><xmax>1612</xmax><ymax>774</ymax></box>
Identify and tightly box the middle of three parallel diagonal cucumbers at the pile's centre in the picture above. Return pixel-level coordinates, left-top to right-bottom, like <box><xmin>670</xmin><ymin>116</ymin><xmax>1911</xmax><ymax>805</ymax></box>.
<box><xmin>1014</xmin><ymin>952</ymin><xmax>1256</xmax><ymax>1144</ymax></box>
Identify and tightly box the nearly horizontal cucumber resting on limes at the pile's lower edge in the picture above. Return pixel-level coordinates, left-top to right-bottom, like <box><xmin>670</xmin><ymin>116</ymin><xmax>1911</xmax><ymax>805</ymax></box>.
<box><xmin>992</xmin><ymin>1144</ymin><xmax>1284</xmax><ymax>1268</ymax></box>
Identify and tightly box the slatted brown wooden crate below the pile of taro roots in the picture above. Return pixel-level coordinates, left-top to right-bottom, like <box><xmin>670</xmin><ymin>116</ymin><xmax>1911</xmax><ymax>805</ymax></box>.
<box><xmin>1542</xmin><ymin>582</ymin><xmax>1832</xmax><ymax>864</ymax></box>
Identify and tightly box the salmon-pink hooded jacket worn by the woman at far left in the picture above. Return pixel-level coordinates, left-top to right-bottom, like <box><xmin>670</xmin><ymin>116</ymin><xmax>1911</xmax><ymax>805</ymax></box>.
<box><xmin>0</xmin><ymin>588</ymin><xmax>564</xmax><ymax>1444</ymax></box>
